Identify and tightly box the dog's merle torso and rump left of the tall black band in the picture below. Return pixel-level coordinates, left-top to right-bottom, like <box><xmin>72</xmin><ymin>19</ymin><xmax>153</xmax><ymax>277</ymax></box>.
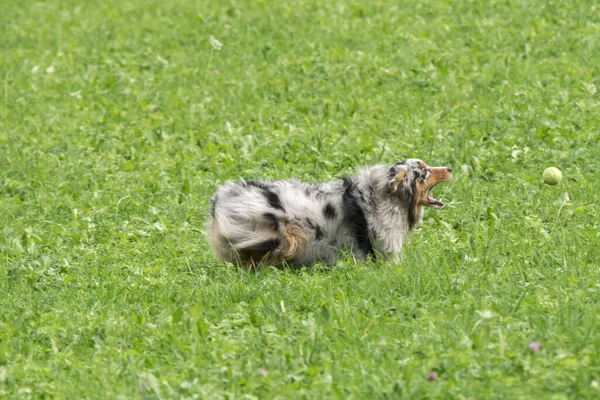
<box><xmin>208</xmin><ymin>180</ymin><xmax>352</xmax><ymax>267</ymax></box>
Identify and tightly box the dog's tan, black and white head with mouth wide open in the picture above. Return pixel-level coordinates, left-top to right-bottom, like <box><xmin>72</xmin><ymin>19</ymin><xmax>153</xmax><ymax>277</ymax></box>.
<box><xmin>389</xmin><ymin>158</ymin><xmax>452</xmax><ymax>208</ymax></box>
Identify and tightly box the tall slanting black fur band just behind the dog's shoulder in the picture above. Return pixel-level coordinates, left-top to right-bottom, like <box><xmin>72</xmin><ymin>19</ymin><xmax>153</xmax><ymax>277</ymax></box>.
<box><xmin>343</xmin><ymin>178</ymin><xmax>375</xmax><ymax>256</ymax></box>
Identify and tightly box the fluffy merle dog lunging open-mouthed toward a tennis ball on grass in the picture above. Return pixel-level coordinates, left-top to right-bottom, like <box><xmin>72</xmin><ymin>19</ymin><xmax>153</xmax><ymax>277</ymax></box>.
<box><xmin>206</xmin><ymin>159</ymin><xmax>452</xmax><ymax>270</ymax></box>
